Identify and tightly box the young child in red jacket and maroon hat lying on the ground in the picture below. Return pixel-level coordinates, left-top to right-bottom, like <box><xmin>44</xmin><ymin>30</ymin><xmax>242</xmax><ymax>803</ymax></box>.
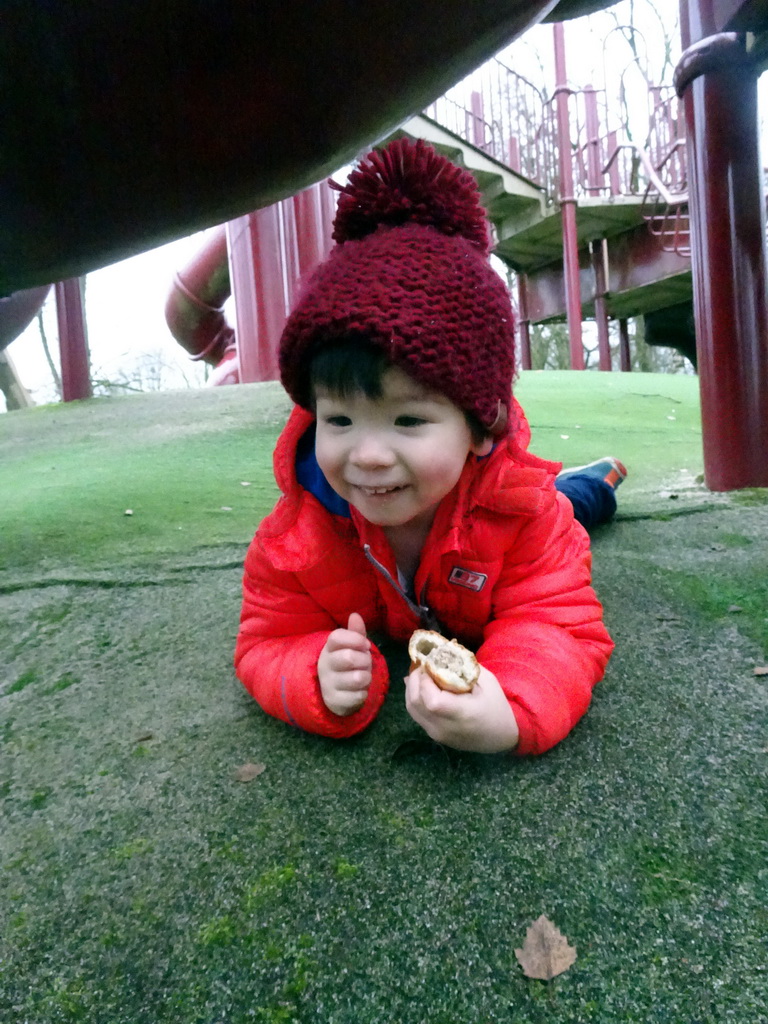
<box><xmin>236</xmin><ymin>140</ymin><xmax>626</xmax><ymax>755</ymax></box>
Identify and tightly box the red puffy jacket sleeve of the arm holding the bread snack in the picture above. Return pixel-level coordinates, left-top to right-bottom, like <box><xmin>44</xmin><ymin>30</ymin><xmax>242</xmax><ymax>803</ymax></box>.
<box><xmin>477</xmin><ymin>495</ymin><xmax>613</xmax><ymax>755</ymax></box>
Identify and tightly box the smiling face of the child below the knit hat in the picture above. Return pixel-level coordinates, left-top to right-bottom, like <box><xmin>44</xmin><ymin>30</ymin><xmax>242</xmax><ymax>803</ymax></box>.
<box><xmin>315</xmin><ymin>367</ymin><xmax>493</xmax><ymax>527</ymax></box>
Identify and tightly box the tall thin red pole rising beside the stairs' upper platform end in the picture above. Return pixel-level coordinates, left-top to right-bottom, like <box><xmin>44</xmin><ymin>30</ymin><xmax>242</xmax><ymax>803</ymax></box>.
<box><xmin>552</xmin><ymin>22</ymin><xmax>584</xmax><ymax>370</ymax></box>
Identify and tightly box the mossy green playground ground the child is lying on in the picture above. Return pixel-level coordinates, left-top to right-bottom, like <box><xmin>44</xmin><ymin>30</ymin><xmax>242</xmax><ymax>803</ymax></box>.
<box><xmin>0</xmin><ymin>373</ymin><xmax>768</xmax><ymax>1024</ymax></box>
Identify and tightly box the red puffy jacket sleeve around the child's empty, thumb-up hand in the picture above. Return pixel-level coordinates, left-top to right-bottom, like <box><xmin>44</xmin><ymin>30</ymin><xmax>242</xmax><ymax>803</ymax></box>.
<box><xmin>234</xmin><ymin>534</ymin><xmax>389</xmax><ymax>738</ymax></box>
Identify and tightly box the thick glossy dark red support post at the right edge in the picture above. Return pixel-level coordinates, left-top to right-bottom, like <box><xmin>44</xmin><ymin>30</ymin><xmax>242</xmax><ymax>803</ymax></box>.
<box><xmin>675</xmin><ymin>11</ymin><xmax>768</xmax><ymax>490</ymax></box>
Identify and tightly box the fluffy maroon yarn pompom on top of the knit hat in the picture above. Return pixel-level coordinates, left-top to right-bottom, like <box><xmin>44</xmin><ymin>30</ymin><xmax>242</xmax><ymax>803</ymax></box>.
<box><xmin>330</xmin><ymin>138</ymin><xmax>489</xmax><ymax>255</ymax></box>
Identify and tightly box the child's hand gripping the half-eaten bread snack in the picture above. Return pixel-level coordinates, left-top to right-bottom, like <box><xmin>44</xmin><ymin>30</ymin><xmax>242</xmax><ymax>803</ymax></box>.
<box><xmin>406</xmin><ymin>667</ymin><xmax>519</xmax><ymax>754</ymax></box>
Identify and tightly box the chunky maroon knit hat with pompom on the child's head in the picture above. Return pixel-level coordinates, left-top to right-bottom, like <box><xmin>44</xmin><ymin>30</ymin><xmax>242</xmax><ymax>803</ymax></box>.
<box><xmin>280</xmin><ymin>138</ymin><xmax>514</xmax><ymax>435</ymax></box>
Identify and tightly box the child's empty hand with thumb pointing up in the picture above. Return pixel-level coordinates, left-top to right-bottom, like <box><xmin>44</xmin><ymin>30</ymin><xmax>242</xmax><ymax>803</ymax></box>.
<box><xmin>317</xmin><ymin>611</ymin><xmax>373</xmax><ymax>716</ymax></box>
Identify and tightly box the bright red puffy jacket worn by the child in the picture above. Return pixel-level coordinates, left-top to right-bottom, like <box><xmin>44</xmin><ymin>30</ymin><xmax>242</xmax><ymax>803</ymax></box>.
<box><xmin>234</xmin><ymin>407</ymin><xmax>613</xmax><ymax>754</ymax></box>
